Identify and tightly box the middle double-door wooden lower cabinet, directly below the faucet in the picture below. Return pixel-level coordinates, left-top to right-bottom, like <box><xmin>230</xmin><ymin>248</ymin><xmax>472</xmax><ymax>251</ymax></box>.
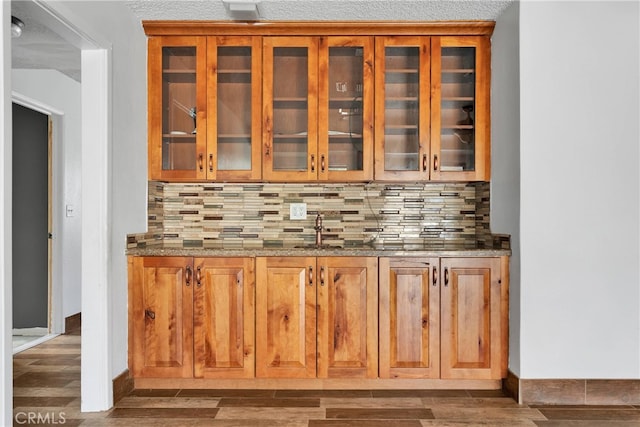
<box><xmin>256</xmin><ymin>257</ymin><xmax>378</xmax><ymax>378</ymax></box>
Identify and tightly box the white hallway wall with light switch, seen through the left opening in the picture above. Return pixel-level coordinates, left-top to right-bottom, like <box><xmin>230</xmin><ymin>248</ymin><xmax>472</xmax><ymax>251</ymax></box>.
<box><xmin>11</xmin><ymin>70</ymin><xmax>82</xmax><ymax>332</ymax></box>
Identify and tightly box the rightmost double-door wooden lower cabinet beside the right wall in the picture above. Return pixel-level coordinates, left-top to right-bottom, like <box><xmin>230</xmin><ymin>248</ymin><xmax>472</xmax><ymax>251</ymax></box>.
<box><xmin>380</xmin><ymin>258</ymin><xmax>508</xmax><ymax>379</ymax></box>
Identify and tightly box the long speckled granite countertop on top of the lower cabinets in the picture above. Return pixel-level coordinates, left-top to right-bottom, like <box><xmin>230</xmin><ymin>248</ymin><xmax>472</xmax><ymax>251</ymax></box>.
<box><xmin>126</xmin><ymin>244</ymin><xmax>511</xmax><ymax>257</ymax></box>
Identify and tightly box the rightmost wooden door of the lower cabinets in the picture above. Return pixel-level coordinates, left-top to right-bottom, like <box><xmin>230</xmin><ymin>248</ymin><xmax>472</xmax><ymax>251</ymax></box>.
<box><xmin>441</xmin><ymin>258</ymin><xmax>502</xmax><ymax>379</ymax></box>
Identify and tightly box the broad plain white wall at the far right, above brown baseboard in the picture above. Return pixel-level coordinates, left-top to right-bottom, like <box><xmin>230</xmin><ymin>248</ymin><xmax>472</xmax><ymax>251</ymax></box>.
<box><xmin>520</xmin><ymin>1</ymin><xmax>640</xmax><ymax>379</ymax></box>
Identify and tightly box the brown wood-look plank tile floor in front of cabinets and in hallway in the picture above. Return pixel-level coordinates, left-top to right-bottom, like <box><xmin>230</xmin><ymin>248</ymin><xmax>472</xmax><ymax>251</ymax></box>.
<box><xmin>13</xmin><ymin>335</ymin><xmax>640</xmax><ymax>427</ymax></box>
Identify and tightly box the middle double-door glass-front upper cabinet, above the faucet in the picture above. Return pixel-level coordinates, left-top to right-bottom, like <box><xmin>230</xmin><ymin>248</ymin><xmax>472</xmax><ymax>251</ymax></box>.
<box><xmin>262</xmin><ymin>37</ymin><xmax>373</xmax><ymax>181</ymax></box>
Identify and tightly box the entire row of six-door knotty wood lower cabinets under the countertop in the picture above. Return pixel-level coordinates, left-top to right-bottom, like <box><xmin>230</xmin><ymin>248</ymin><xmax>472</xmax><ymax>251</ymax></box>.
<box><xmin>129</xmin><ymin>256</ymin><xmax>509</xmax><ymax>380</ymax></box>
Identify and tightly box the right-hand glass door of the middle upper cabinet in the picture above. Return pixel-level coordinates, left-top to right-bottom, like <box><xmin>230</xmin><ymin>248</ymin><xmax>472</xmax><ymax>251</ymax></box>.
<box><xmin>318</xmin><ymin>37</ymin><xmax>373</xmax><ymax>181</ymax></box>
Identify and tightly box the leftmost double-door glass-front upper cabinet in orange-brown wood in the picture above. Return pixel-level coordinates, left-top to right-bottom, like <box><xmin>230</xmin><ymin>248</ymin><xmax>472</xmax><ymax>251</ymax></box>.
<box><xmin>149</xmin><ymin>36</ymin><xmax>261</xmax><ymax>181</ymax></box>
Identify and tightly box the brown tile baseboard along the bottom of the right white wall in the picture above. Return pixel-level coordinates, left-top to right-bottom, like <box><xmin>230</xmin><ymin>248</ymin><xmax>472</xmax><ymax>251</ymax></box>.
<box><xmin>503</xmin><ymin>372</ymin><xmax>640</xmax><ymax>405</ymax></box>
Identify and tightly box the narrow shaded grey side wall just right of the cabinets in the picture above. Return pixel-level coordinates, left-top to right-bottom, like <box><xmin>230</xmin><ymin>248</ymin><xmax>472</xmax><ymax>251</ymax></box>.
<box><xmin>491</xmin><ymin>3</ymin><xmax>520</xmax><ymax>375</ymax></box>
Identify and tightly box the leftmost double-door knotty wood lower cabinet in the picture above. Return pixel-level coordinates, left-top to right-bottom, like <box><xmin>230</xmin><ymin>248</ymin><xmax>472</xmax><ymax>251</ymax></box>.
<box><xmin>129</xmin><ymin>257</ymin><xmax>255</xmax><ymax>378</ymax></box>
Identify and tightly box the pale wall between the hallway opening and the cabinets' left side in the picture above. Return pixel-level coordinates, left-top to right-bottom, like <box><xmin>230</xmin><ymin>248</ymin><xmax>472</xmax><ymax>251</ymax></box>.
<box><xmin>53</xmin><ymin>1</ymin><xmax>147</xmax><ymax>384</ymax></box>
